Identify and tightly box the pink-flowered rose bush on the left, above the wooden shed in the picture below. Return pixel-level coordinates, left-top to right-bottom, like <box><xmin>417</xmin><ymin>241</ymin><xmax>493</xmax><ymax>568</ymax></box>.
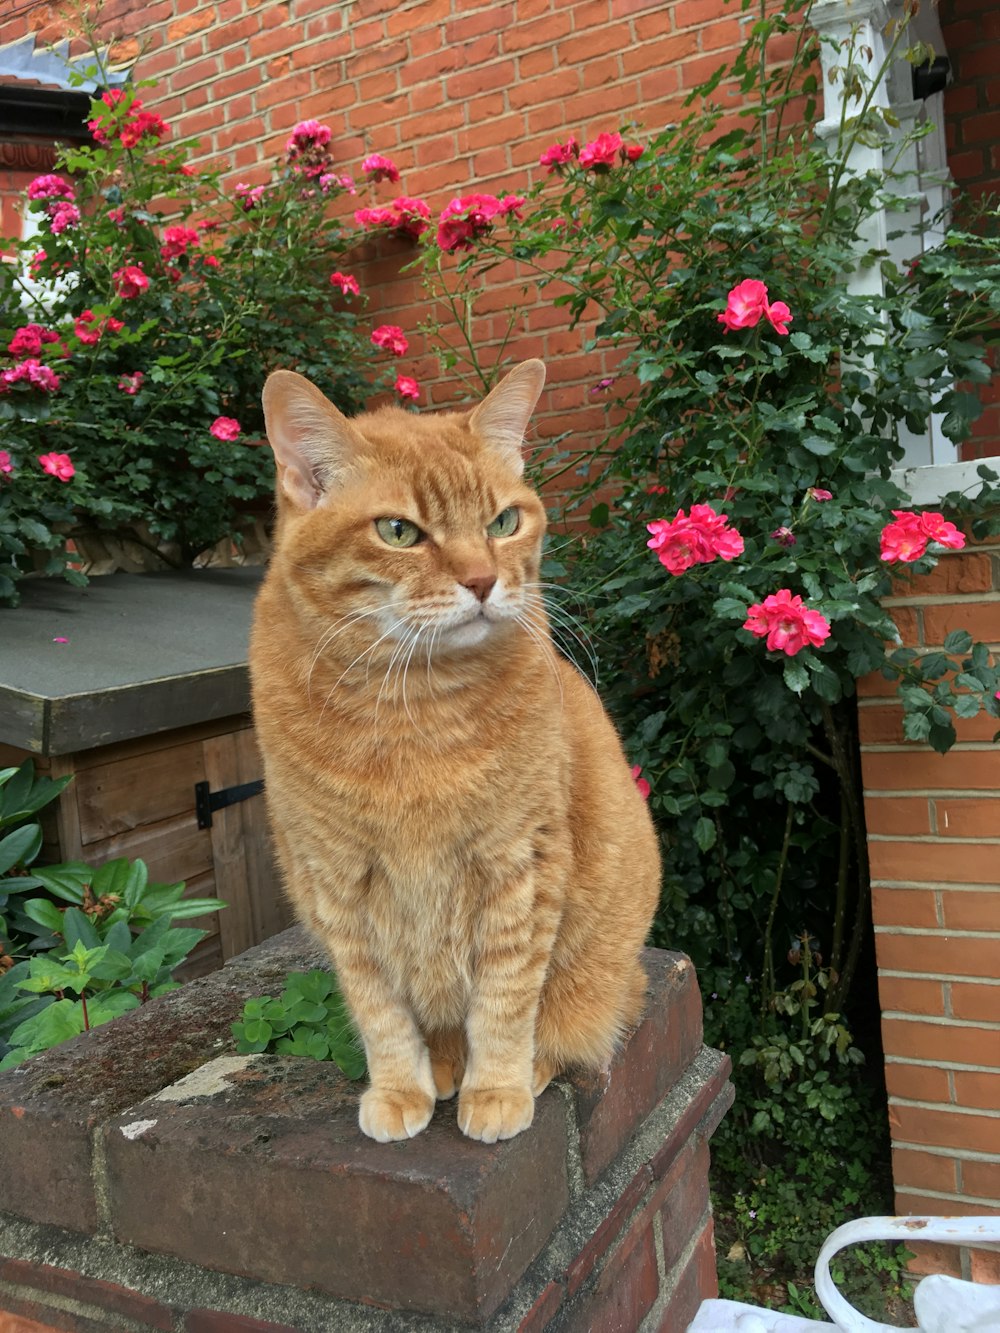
<box><xmin>0</xmin><ymin>54</ymin><xmax>429</xmax><ymax>603</ymax></box>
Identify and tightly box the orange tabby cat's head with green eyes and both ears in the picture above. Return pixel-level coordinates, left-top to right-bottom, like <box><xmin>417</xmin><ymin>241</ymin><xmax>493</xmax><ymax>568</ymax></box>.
<box><xmin>264</xmin><ymin>360</ymin><xmax>545</xmax><ymax>653</ymax></box>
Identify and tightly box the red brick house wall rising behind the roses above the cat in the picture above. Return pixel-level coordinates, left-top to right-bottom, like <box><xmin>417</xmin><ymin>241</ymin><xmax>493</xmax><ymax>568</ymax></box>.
<box><xmin>0</xmin><ymin>0</ymin><xmax>741</xmax><ymax>458</ymax></box>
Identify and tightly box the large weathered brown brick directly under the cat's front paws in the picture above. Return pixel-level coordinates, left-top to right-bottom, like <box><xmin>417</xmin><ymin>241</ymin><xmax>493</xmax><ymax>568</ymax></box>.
<box><xmin>104</xmin><ymin>1056</ymin><xmax>568</xmax><ymax>1318</ymax></box>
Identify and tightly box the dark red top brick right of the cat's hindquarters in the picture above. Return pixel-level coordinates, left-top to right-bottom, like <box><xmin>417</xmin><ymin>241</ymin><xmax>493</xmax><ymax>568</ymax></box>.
<box><xmin>575</xmin><ymin>950</ymin><xmax>701</xmax><ymax>1182</ymax></box>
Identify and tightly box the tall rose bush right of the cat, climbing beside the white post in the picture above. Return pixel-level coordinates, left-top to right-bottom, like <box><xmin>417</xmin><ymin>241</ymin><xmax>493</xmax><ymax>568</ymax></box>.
<box><xmin>425</xmin><ymin>3</ymin><xmax>1000</xmax><ymax>1029</ymax></box>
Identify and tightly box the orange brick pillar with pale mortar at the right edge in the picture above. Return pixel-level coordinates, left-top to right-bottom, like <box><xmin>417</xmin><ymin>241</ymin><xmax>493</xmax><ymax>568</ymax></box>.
<box><xmin>859</xmin><ymin>544</ymin><xmax>1000</xmax><ymax>1281</ymax></box>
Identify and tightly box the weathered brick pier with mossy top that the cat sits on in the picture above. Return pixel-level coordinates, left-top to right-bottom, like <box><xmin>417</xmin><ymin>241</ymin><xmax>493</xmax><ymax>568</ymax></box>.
<box><xmin>0</xmin><ymin>930</ymin><xmax>732</xmax><ymax>1333</ymax></box>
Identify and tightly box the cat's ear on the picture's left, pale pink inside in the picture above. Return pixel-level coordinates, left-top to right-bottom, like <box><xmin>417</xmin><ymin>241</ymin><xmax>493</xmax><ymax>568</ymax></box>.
<box><xmin>263</xmin><ymin>371</ymin><xmax>361</xmax><ymax>509</ymax></box>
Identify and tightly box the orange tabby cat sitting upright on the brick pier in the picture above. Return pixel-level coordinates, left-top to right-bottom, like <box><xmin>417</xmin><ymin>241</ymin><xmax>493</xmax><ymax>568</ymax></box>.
<box><xmin>251</xmin><ymin>361</ymin><xmax>659</xmax><ymax>1142</ymax></box>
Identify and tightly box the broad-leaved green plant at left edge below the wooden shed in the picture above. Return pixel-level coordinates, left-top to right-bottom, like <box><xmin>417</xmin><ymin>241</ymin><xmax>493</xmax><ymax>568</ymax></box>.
<box><xmin>0</xmin><ymin>760</ymin><xmax>225</xmax><ymax>1069</ymax></box>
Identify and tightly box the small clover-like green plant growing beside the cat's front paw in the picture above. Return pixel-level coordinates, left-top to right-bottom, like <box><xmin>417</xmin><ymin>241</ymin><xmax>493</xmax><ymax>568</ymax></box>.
<box><xmin>232</xmin><ymin>968</ymin><xmax>367</xmax><ymax>1078</ymax></box>
